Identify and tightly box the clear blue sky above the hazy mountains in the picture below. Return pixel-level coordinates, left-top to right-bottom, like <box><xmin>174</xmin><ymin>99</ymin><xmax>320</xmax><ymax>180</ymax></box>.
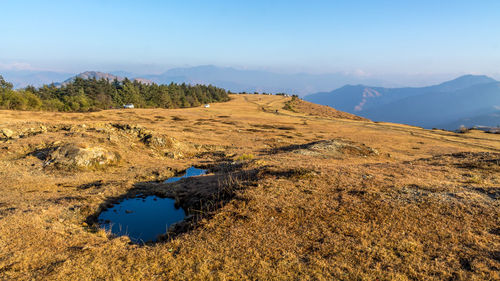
<box><xmin>0</xmin><ymin>0</ymin><xmax>500</xmax><ymax>74</ymax></box>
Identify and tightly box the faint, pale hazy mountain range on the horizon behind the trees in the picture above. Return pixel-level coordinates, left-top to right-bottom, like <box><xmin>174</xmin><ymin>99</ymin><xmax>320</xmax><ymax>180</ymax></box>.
<box><xmin>0</xmin><ymin>65</ymin><xmax>394</xmax><ymax>95</ymax></box>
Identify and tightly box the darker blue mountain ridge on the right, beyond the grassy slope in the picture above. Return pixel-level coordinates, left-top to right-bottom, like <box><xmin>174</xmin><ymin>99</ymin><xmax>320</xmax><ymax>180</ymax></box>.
<box><xmin>305</xmin><ymin>75</ymin><xmax>500</xmax><ymax>130</ymax></box>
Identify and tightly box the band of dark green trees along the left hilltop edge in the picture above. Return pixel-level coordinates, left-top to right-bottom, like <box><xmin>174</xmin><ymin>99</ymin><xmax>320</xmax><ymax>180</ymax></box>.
<box><xmin>0</xmin><ymin>75</ymin><xmax>230</xmax><ymax>112</ymax></box>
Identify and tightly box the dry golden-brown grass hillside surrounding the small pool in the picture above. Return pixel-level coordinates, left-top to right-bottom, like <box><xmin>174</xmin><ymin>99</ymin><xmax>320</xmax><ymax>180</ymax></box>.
<box><xmin>0</xmin><ymin>95</ymin><xmax>500</xmax><ymax>280</ymax></box>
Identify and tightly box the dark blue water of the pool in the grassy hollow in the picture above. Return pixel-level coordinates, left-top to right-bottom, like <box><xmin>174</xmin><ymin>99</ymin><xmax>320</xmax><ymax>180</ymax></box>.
<box><xmin>98</xmin><ymin>167</ymin><xmax>206</xmax><ymax>243</ymax></box>
